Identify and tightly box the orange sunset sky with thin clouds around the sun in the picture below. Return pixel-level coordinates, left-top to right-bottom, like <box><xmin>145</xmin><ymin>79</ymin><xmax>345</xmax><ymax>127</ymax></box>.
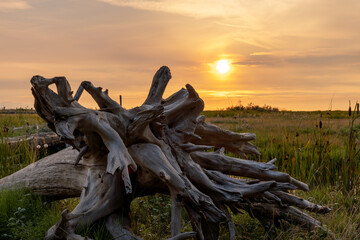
<box><xmin>0</xmin><ymin>0</ymin><xmax>360</xmax><ymax>110</ymax></box>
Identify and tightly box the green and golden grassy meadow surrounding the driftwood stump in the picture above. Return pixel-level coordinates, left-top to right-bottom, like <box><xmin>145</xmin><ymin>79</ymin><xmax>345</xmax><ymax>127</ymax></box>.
<box><xmin>0</xmin><ymin>109</ymin><xmax>360</xmax><ymax>239</ymax></box>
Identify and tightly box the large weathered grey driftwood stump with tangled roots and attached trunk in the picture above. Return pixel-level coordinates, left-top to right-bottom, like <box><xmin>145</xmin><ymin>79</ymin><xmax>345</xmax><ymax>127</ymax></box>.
<box><xmin>0</xmin><ymin>66</ymin><xmax>330</xmax><ymax>240</ymax></box>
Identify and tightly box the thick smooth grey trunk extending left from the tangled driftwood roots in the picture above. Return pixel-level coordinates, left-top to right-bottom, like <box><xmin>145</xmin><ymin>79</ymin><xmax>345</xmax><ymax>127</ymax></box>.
<box><xmin>0</xmin><ymin>148</ymin><xmax>86</xmax><ymax>198</ymax></box>
